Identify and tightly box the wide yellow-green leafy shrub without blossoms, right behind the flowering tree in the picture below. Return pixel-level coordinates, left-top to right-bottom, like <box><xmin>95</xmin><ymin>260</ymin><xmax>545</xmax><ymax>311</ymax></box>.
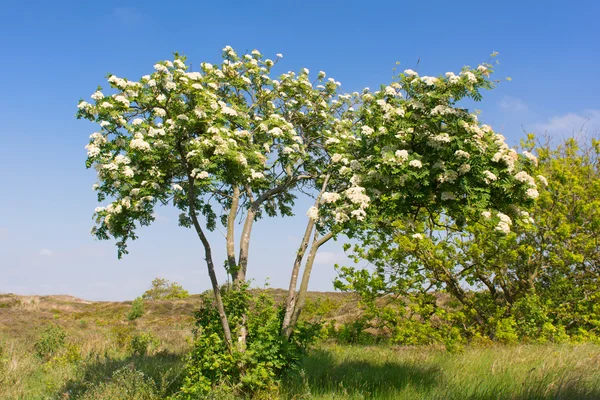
<box><xmin>336</xmin><ymin>135</ymin><xmax>600</xmax><ymax>344</ymax></box>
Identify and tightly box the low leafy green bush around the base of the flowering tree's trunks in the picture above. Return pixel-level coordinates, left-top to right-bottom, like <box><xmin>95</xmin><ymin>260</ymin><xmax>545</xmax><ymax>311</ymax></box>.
<box><xmin>179</xmin><ymin>287</ymin><xmax>320</xmax><ymax>399</ymax></box>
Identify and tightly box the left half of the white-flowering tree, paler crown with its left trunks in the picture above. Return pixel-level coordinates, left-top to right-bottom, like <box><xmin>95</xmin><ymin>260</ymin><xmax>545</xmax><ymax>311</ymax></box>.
<box><xmin>78</xmin><ymin>47</ymin><xmax>348</xmax><ymax>348</ymax></box>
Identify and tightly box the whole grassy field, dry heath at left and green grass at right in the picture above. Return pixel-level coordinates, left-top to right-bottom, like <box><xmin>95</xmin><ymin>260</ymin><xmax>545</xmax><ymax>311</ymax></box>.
<box><xmin>0</xmin><ymin>294</ymin><xmax>600</xmax><ymax>400</ymax></box>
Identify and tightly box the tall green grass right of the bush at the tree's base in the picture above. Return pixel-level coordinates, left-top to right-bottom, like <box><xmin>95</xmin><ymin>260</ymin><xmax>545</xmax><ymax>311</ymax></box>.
<box><xmin>283</xmin><ymin>344</ymin><xmax>600</xmax><ymax>400</ymax></box>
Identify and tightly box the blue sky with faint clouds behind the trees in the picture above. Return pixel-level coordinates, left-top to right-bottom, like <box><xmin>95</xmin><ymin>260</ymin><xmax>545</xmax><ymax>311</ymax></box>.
<box><xmin>0</xmin><ymin>0</ymin><xmax>600</xmax><ymax>300</ymax></box>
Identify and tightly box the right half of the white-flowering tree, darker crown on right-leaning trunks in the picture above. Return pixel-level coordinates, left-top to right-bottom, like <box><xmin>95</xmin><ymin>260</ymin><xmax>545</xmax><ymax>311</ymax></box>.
<box><xmin>283</xmin><ymin>57</ymin><xmax>544</xmax><ymax>336</ymax></box>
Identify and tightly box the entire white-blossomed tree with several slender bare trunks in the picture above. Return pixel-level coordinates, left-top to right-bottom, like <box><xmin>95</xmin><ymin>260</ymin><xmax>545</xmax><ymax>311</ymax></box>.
<box><xmin>78</xmin><ymin>47</ymin><xmax>537</xmax><ymax>372</ymax></box>
